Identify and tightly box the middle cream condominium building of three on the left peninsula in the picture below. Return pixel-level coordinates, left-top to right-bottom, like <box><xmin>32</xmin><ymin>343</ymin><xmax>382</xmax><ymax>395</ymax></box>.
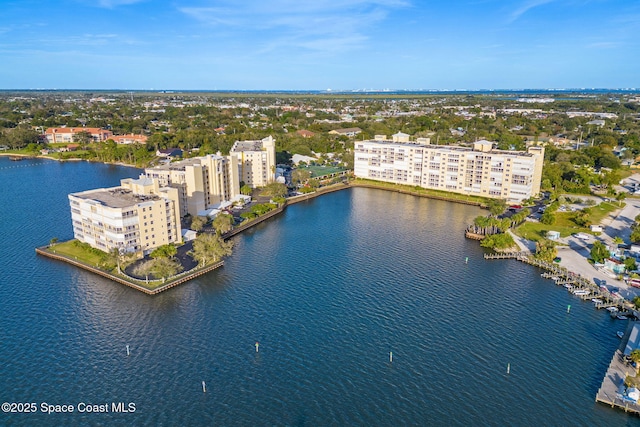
<box><xmin>145</xmin><ymin>154</ymin><xmax>240</xmax><ymax>216</ymax></box>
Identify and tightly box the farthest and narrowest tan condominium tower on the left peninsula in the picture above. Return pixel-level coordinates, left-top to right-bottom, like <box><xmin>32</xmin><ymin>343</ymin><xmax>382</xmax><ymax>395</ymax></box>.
<box><xmin>229</xmin><ymin>136</ymin><xmax>276</xmax><ymax>188</ymax></box>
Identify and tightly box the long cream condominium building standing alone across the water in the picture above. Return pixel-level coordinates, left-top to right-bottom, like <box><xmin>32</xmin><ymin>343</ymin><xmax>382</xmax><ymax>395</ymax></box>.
<box><xmin>354</xmin><ymin>133</ymin><xmax>544</xmax><ymax>201</ymax></box>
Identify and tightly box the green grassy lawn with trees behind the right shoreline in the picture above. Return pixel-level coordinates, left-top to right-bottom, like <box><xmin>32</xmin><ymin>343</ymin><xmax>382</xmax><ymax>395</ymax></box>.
<box><xmin>514</xmin><ymin>202</ymin><xmax>624</xmax><ymax>242</ymax></box>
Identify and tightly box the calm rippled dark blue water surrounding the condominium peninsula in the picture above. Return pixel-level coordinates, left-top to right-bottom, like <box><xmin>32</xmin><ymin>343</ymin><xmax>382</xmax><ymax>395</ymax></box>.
<box><xmin>0</xmin><ymin>158</ymin><xmax>639</xmax><ymax>426</ymax></box>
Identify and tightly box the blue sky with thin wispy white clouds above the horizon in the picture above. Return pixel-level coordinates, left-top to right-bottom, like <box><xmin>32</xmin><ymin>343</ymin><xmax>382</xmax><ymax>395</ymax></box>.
<box><xmin>0</xmin><ymin>0</ymin><xmax>640</xmax><ymax>90</ymax></box>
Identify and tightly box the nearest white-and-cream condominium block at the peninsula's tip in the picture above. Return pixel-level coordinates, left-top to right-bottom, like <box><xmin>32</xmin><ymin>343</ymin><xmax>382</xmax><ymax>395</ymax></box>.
<box><xmin>69</xmin><ymin>178</ymin><xmax>182</xmax><ymax>254</ymax></box>
